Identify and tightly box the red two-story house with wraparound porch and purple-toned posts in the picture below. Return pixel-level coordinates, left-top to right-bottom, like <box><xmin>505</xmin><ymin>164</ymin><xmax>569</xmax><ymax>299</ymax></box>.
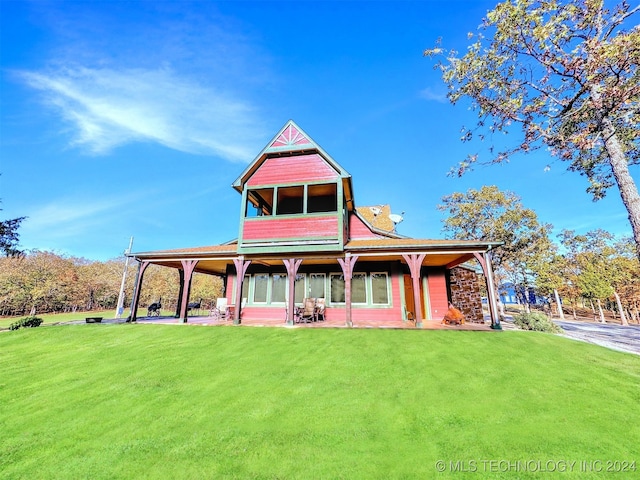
<box><xmin>131</xmin><ymin>121</ymin><xmax>500</xmax><ymax>328</ymax></box>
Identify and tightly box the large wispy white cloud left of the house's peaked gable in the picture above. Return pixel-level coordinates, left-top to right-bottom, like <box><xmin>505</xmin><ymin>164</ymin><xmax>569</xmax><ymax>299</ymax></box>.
<box><xmin>20</xmin><ymin>67</ymin><xmax>263</xmax><ymax>162</ymax></box>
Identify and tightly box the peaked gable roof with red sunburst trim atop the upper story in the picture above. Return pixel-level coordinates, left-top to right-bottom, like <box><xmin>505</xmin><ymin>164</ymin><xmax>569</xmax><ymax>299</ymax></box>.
<box><xmin>231</xmin><ymin>120</ymin><xmax>353</xmax><ymax>210</ymax></box>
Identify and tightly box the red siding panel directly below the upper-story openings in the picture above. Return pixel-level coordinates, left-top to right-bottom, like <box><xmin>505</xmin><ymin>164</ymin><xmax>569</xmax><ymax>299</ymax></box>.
<box><xmin>242</xmin><ymin>215</ymin><xmax>339</xmax><ymax>242</ymax></box>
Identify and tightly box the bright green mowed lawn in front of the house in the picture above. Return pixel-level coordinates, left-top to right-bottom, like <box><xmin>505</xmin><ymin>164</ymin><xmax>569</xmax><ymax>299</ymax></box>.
<box><xmin>0</xmin><ymin>324</ymin><xmax>640</xmax><ymax>479</ymax></box>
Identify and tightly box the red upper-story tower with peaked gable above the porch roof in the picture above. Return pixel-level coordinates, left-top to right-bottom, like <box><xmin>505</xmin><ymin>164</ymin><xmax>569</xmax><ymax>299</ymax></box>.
<box><xmin>232</xmin><ymin>120</ymin><xmax>354</xmax><ymax>254</ymax></box>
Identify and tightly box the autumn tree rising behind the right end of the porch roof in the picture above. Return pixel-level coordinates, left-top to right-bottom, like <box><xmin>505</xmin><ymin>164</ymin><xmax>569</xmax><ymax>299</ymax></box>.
<box><xmin>438</xmin><ymin>185</ymin><xmax>552</xmax><ymax>308</ymax></box>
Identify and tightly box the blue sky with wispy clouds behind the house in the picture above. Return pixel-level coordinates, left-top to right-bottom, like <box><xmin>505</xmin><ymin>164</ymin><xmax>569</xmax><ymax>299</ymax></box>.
<box><xmin>0</xmin><ymin>0</ymin><xmax>640</xmax><ymax>260</ymax></box>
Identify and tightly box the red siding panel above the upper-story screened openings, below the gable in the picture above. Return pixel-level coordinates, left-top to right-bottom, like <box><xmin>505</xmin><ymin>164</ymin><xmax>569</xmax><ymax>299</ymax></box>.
<box><xmin>247</xmin><ymin>153</ymin><xmax>338</xmax><ymax>187</ymax></box>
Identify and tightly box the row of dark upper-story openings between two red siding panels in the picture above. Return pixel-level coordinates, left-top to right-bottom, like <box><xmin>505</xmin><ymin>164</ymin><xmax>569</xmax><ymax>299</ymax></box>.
<box><xmin>245</xmin><ymin>183</ymin><xmax>338</xmax><ymax>217</ymax></box>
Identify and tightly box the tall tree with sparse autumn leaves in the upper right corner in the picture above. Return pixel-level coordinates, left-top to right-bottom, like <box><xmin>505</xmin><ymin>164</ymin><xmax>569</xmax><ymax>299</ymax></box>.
<box><xmin>424</xmin><ymin>0</ymin><xmax>640</xmax><ymax>258</ymax></box>
